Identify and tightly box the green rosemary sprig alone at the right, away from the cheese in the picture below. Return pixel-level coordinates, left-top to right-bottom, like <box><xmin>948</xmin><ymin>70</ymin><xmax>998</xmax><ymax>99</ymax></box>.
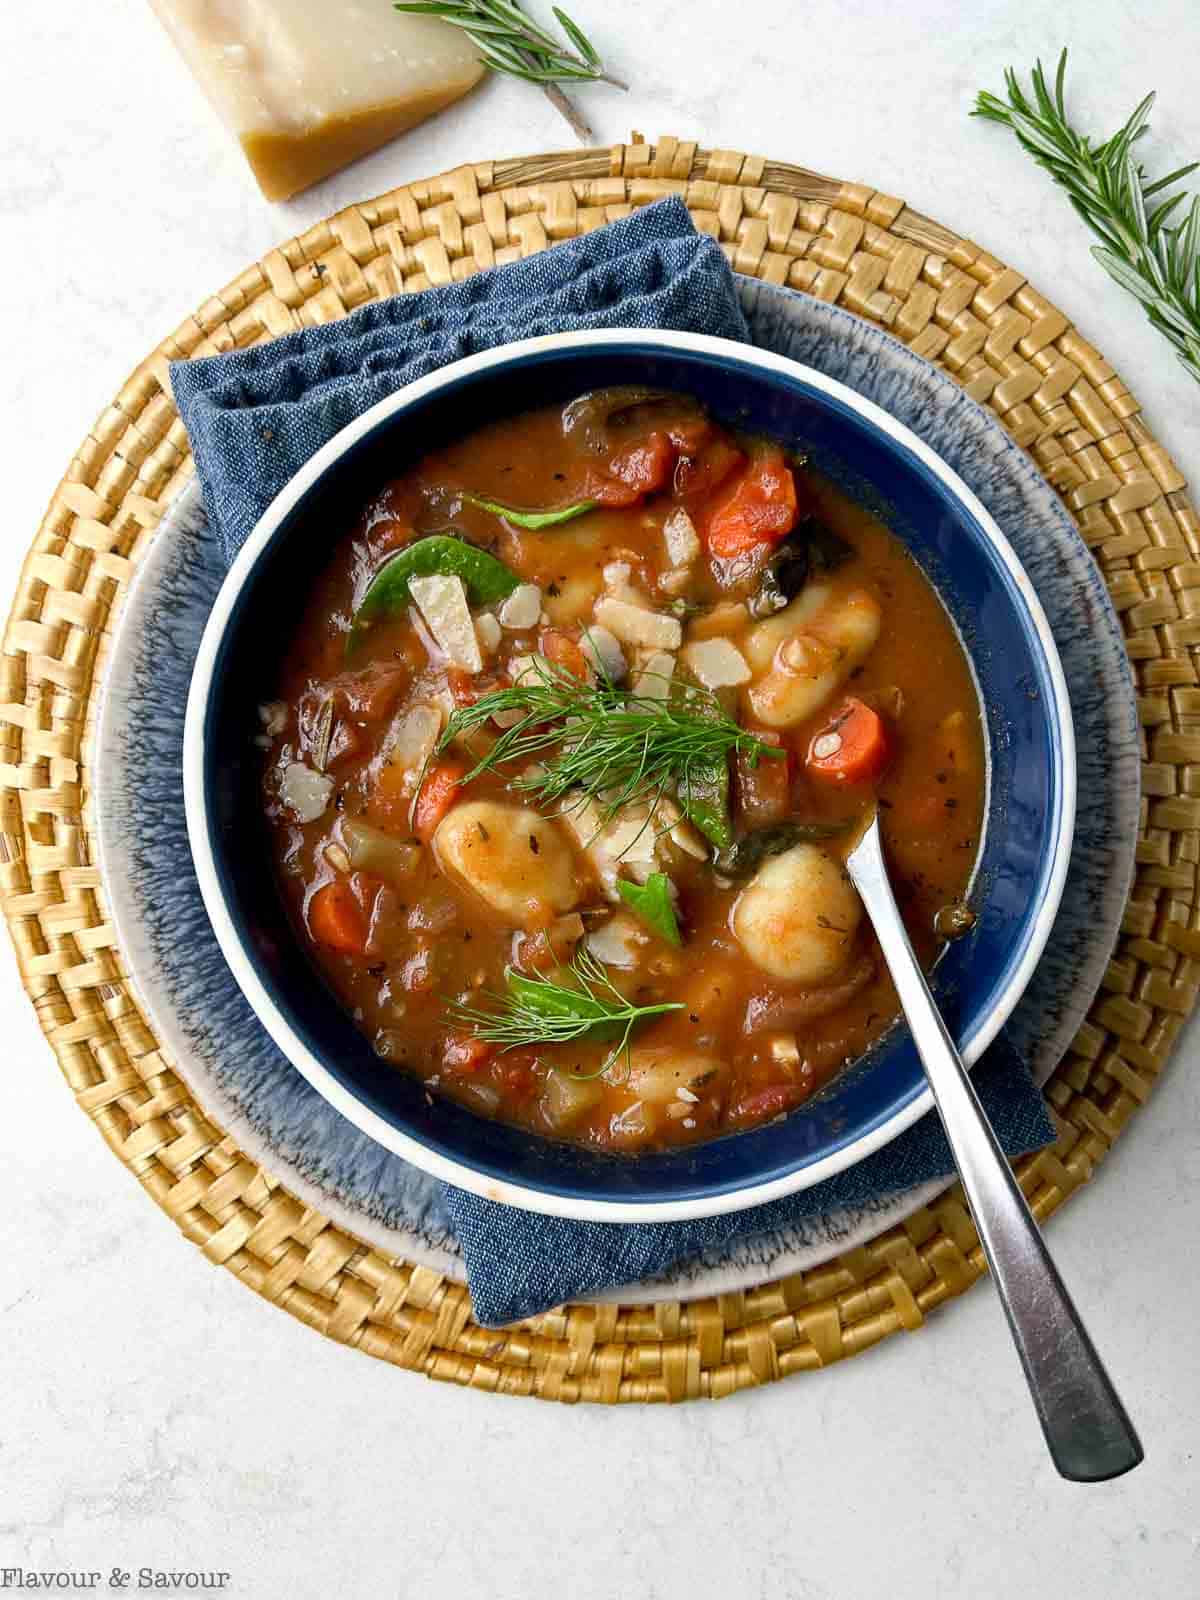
<box><xmin>971</xmin><ymin>50</ymin><xmax>1200</xmax><ymax>381</ymax></box>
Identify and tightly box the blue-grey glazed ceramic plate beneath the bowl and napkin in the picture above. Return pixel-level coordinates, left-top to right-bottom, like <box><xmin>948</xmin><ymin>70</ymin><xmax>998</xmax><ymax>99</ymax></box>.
<box><xmin>96</xmin><ymin>282</ymin><xmax>1139</xmax><ymax>1302</ymax></box>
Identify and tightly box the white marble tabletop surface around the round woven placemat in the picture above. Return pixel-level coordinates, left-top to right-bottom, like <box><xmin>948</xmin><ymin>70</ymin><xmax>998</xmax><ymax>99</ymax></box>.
<box><xmin>0</xmin><ymin>0</ymin><xmax>1200</xmax><ymax>1600</ymax></box>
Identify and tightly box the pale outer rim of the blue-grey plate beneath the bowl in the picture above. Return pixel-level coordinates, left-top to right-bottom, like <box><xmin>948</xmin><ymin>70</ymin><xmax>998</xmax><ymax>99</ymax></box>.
<box><xmin>94</xmin><ymin>280</ymin><xmax>1138</xmax><ymax>1302</ymax></box>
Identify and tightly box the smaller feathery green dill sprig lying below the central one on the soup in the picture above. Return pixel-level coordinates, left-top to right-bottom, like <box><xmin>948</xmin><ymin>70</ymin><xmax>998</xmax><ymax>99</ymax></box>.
<box><xmin>450</xmin><ymin>949</ymin><xmax>683</xmax><ymax>1077</ymax></box>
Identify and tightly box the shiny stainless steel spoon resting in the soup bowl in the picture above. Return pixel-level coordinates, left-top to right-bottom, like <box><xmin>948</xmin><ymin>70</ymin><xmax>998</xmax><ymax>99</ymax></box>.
<box><xmin>846</xmin><ymin>818</ymin><xmax>1142</xmax><ymax>1483</ymax></box>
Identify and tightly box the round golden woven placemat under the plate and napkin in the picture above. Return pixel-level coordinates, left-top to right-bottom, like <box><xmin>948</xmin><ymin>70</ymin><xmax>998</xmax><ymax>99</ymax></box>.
<box><xmin>0</xmin><ymin>134</ymin><xmax>1200</xmax><ymax>1403</ymax></box>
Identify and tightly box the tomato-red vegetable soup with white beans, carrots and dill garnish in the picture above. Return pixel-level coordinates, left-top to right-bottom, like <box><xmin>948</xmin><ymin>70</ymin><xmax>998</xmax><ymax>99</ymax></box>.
<box><xmin>259</xmin><ymin>389</ymin><xmax>984</xmax><ymax>1152</ymax></box>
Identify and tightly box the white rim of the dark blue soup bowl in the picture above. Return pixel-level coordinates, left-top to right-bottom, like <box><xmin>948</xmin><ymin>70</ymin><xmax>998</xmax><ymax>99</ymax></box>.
<box><xmin>182</xmin><ymin>328</ymin><xmax>1077</xmax><ymax>1222</ymax></box>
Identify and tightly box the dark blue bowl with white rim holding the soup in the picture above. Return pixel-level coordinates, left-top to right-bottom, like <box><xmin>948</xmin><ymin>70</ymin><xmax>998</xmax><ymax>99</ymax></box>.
<box><xmin>184</xmin><ymin>330</ymin><xmax>1075</xmax><ymax>1222</ymax></box>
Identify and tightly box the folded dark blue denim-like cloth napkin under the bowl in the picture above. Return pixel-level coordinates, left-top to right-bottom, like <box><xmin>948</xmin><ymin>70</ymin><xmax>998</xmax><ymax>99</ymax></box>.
<box><xmin>171</xmin><ymin>200</ymin><xmax>1054</xmax><ymax>1326</ymax></box>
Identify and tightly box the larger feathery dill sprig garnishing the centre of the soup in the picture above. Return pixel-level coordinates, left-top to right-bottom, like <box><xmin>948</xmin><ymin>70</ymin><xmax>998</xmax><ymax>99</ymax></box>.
<box><xmin>438</xmin><ymin>656</ymin><xmax>784</xmax><ymax>821</ymax></box>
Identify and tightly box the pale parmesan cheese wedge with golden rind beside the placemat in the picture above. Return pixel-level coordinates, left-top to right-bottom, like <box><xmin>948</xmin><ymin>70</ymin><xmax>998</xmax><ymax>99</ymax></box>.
<box><xmin>150</xmin><ymin>0</ymin><xmax>483</xmax><ymax>200</ymax></box>
